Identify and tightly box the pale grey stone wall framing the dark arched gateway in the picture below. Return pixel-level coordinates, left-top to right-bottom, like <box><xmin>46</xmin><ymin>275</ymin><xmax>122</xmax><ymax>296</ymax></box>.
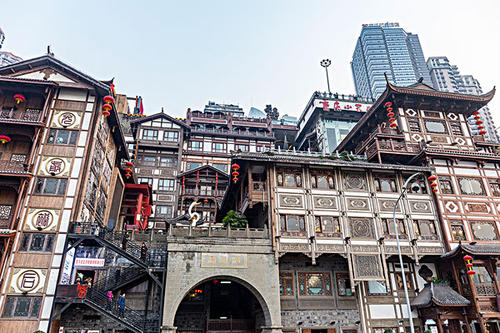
<box><xmin>162</xmin><ymin>252</ymin><xmax>281</xmax><ymax>333</ymax></box>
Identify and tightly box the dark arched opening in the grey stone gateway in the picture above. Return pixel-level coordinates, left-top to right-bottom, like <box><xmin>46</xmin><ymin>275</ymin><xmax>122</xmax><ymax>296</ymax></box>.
<box><xmin>174</xmin><ymin>277</ymin><xmax>269</xmax><ymax>333</ymax></box>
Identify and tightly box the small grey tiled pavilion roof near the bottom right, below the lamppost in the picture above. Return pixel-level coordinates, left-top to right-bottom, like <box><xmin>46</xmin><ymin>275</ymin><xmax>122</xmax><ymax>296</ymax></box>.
<box><xmin>411</xmin><ymin>282</ymin><xmax>470</xmax><ymax>307</ymax></box>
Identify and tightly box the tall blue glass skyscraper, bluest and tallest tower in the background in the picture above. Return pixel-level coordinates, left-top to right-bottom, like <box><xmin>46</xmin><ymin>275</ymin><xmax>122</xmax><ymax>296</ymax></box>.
<box><xmin>351</xmin><ymin>23</ymin><xmax>431</xmax><ymax>98</ymax></box>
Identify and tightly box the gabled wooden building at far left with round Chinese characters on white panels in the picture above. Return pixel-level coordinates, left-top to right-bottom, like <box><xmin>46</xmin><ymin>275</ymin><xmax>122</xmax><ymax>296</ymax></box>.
<box><xmin>0</xmin><ymin>54</ymin><xmax>162</xmax><ymax>332</ymax></box>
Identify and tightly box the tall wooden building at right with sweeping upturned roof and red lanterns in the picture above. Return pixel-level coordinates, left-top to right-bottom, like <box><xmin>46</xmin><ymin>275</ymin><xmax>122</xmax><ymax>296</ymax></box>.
<box><xmin>338</xmin><ymin>76</ymin><xmax>500</xmax><ymax>333</ymax></box>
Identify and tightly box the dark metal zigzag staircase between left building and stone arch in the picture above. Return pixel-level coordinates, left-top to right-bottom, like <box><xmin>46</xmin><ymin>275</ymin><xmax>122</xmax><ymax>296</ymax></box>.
<box><xmin>51</xmin><ymin>222</ymin><xmax>166</xmax><ymax>333</ymax></box>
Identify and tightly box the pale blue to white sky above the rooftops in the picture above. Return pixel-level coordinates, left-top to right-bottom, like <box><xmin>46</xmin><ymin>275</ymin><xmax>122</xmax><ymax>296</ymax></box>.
<box><xmin>0</xmin><ymin>0</ymin><xmax>500</xmax><ymax>120</ymax></box>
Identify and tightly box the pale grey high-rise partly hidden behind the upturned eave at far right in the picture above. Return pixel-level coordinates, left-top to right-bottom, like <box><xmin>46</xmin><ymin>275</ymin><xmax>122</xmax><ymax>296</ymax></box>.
<box><xmin>427</xmin><ymin>56</ymin><xmax>500</xmax><ymax>142</ymax></box>
